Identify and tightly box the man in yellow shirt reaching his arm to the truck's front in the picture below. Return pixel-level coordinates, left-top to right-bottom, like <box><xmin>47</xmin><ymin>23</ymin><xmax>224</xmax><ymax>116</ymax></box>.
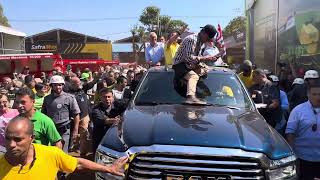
<box><xmin>0</xmin><ymin>116</ymin><xmax>128</xmax><ymax>180</ymax></box>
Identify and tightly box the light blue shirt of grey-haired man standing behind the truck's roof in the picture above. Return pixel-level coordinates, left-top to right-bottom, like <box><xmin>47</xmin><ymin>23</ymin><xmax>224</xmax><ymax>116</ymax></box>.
<box><xmin>145</xmin><ymin>43</ymin><xmax>164</xmax><ymax>64</ymax></box>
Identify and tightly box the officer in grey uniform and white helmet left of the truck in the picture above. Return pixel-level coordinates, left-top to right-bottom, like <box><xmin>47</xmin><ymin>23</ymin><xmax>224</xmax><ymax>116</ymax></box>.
<box><xmin>42</xmin><ymin>75</ymin><xmax>80</xmax><ymax>152</ymax></box>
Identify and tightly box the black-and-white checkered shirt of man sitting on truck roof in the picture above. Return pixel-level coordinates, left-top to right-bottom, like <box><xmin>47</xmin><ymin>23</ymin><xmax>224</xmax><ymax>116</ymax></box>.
<box><xmin>173</xmin><ymin>34</ymin><xmax>202</xmax><ymax>69</ymax></box>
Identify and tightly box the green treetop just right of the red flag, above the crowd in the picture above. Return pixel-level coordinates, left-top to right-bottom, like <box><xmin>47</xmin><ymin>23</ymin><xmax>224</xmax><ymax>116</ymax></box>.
<box><xmin>223</xmin><ymin>16</ymin><xmax>246</xmax><ymax>37</ymax></box>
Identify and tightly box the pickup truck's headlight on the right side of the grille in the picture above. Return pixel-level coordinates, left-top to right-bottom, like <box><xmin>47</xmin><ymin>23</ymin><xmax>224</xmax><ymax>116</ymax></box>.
<box><xmin>266</xmin><ymin>156</ymin><xmax>297</xmax><ymax>180</ymax></box>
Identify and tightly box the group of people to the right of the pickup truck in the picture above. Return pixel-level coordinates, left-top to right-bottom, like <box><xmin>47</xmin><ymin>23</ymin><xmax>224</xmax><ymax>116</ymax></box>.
<box><xmin>239</xmin><ymin>60</ymin><xmax>320</xmax><ymax>180</ymax></box>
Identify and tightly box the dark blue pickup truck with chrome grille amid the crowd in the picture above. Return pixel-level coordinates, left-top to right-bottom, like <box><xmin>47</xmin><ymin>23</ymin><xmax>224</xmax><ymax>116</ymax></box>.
<box><xmin>95</xmin><ymin>67</ymin><xmax>296</xmax><ymax>180</ymax></box>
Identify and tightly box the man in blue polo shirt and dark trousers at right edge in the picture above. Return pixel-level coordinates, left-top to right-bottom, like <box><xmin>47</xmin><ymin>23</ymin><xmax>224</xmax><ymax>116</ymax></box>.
<box><xmin>286</xmin><ymin>80</ymin><xmax>320</xmax><ymax>179</ymax></box>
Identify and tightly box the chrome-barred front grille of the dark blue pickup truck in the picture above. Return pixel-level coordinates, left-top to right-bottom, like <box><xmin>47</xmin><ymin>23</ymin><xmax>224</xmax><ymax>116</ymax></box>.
<box><xmin>127</xmin><ymin>153</ymin><xmax>265</xmax><ymax>180</ymax></box>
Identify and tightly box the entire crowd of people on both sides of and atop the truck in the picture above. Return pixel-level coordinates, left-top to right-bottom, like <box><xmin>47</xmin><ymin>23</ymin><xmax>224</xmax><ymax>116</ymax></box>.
<box><xmin>0</xmin><ymin>22</ymin><xmax>320</xmax><ymax>179</ymax></box>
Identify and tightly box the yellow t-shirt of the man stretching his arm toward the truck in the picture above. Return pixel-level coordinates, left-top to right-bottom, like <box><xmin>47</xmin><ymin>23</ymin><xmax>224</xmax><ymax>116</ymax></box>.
<box><xmin>0</xmin><ymin>144</ymin><xmax>78</xmax><ymax>180</ymax></box>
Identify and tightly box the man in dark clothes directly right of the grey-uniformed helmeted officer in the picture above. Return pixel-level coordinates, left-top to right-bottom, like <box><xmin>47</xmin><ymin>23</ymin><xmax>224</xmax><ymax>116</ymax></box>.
<box><xmin>70</xmin><ymin>77</ymin><xmax>92</xmax><ymax>157</ymax></box>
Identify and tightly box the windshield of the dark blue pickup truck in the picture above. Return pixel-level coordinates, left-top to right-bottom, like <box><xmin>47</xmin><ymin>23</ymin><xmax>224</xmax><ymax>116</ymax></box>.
<box><xmin>135</xmin><ymin>72</ymin><xmax>251</xmax><ymax>108</ymax></box>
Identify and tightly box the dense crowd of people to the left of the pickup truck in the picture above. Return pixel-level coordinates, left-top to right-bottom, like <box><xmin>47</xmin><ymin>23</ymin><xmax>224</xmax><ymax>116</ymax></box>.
<box><xmin>0</xmin><ymin>66</ymin><xmax>146</xmax><ymax>179</ymax></box>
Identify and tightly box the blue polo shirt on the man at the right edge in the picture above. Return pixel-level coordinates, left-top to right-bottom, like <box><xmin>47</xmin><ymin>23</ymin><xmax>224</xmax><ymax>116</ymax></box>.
<box><xmin>286</xmin><ymin>101</ymin><xmax>320</xmax><ymax>162</ymax></box>
